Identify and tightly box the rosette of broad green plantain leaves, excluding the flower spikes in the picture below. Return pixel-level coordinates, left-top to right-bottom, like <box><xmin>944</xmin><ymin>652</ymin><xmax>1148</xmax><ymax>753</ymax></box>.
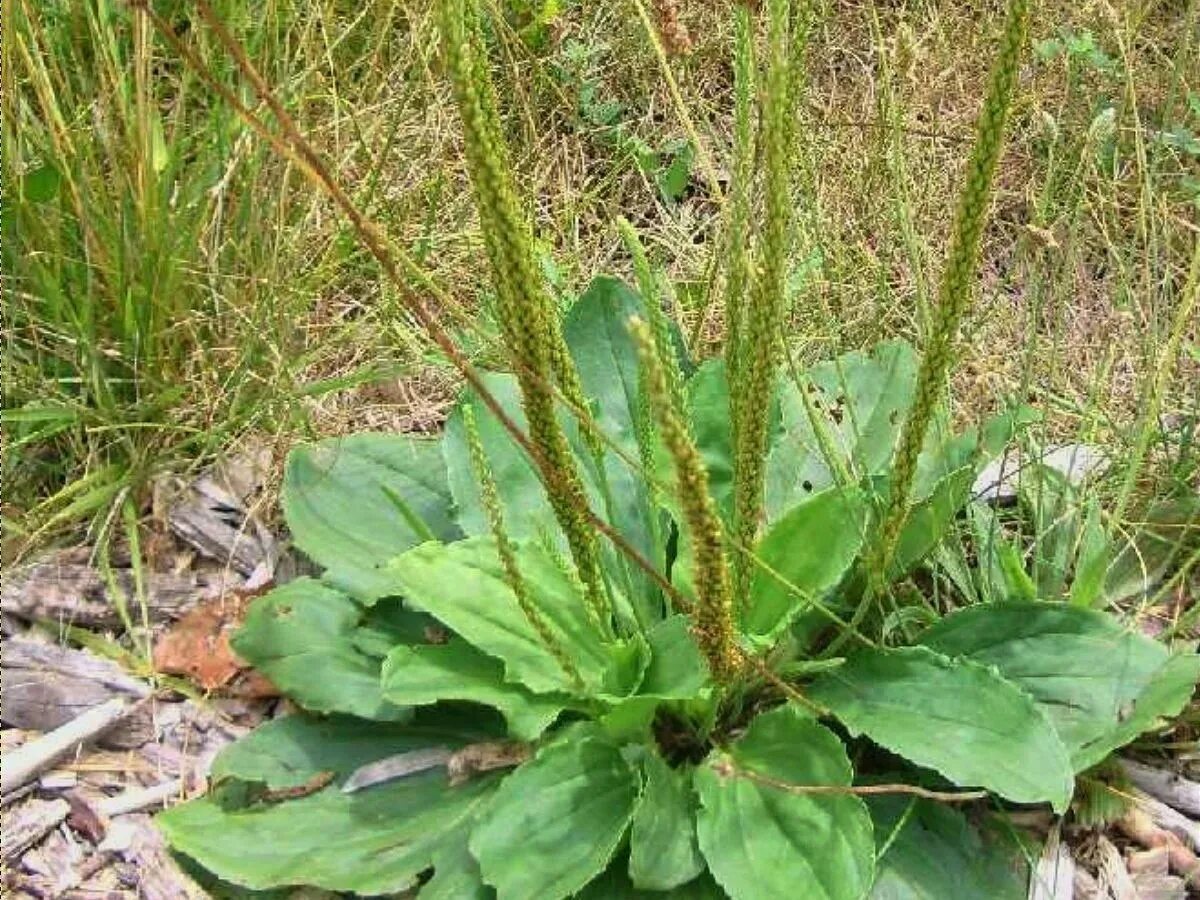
<box><xmin>158</xmin><ymin>278</ymin><xmax>1200</xmax><ymax>900</ymax></box>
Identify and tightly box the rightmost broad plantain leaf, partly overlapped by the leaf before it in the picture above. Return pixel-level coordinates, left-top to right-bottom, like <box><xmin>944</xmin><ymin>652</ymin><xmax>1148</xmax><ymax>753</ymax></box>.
<box><xmin>920</xmin><ymin>601</ymin><xmax>1200</xmax><ymax>772</ymax></box>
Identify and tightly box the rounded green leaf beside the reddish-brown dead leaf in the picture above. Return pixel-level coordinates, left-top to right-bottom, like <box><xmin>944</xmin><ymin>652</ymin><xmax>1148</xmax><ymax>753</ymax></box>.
<box><xmin>233</xmin><ymin>578</ymin><xmax>409</xmax><ymax>720</ymax></box>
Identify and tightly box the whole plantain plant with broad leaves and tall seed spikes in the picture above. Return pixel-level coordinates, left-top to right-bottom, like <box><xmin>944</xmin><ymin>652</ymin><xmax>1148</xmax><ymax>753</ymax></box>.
<box><xmin>158</xmin><ymin>0</ymin><xmax>1200</xmax><ymax>900</ymax></box>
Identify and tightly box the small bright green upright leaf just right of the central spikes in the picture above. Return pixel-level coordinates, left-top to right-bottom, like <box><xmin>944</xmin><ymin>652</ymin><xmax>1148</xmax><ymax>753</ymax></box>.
<box><xmin>743</xmin><ymin>487</ymin><xmax>868</xmax><ymax>642</ymax></box>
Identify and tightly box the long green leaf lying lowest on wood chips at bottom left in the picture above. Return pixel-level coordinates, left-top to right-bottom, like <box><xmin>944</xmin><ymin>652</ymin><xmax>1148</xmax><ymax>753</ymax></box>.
<box><xmin>156</xmin><ymin>769</ymin><xmax>498</xmax><ymax>895</ymax></box>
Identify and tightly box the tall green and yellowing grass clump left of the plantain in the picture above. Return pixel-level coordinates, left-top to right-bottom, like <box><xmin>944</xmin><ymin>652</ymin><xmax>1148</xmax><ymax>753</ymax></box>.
<box><xmin>2</xmin><ymin>0</ymin><xmax>400</xmax><ymax>554</ymax></box>
